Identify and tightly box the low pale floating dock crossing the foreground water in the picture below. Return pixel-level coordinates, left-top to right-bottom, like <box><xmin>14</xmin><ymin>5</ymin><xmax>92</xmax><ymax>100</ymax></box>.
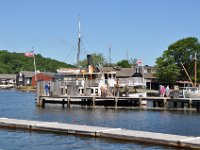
<box><xmin>0</xmin><ymin>118</ymin><xmax>200</xmax><ymax>149</ymax></box>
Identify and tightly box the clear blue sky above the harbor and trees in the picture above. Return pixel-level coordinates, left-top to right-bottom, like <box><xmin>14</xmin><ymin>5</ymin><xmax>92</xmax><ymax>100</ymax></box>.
<box><xmin>0</xmin><ymin>0</ymin><xmax>200</xmax><ymax>66</ymax></box>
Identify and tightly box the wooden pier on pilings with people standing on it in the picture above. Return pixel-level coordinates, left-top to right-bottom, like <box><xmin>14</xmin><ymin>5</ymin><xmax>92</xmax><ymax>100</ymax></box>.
<box><xmin>36</xmin><ymin>95</ymin><xmax>200</xmax><ymax>111</ymax></box>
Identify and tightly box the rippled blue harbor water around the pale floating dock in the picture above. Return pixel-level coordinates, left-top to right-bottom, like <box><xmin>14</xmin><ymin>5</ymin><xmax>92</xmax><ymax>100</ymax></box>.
<box><xmin>0</xmin><ymin>90</ymin><xmax>200</xmax><ymax>150</ymax></box>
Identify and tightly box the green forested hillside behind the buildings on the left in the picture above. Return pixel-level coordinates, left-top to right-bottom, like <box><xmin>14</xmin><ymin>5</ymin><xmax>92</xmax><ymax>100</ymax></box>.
<box><xmin>0</xmin><ymin>50</ymin><xmax>75</xmax><ymax>74</ymax></box>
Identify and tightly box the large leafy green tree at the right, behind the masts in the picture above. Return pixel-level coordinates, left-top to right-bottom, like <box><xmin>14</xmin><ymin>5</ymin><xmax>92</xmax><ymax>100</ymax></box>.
<box><xmin>156</xmin><ymin>37</ymin><xmax>200</xmax><ymax>83</ymax></box>
